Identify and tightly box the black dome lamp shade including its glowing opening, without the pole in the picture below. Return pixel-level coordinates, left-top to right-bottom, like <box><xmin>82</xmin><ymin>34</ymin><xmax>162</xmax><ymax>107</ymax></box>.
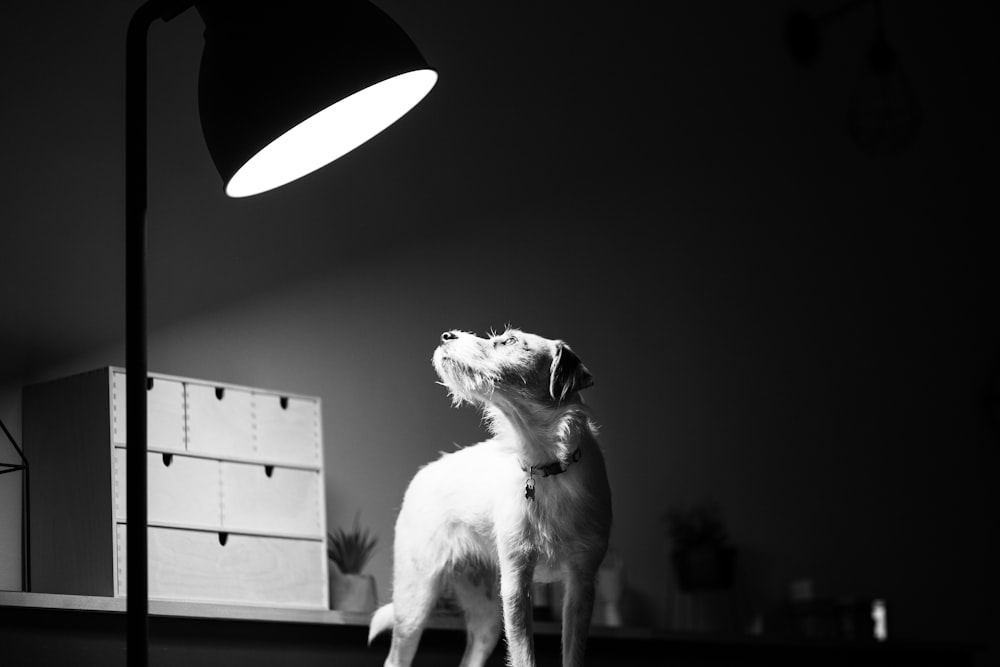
<box><xmin>195</xmin><ymin>0</ymin><xmax>437</xmax><ymax>197</ymax></box>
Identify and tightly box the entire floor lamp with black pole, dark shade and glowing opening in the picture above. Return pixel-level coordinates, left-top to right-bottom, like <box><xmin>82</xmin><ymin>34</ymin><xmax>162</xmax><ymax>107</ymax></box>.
<box><xmin>125</xmin><ymin>0</ymin><xmax>437</xmax><ymax>667</ymax></box>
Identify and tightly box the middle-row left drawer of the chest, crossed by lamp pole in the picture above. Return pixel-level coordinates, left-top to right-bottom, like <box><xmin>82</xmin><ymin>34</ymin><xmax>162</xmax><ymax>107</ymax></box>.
<box><xmin>115</xmin><ymin>447</ymin><xmax>222</xmax><ymax>528</ymax></box>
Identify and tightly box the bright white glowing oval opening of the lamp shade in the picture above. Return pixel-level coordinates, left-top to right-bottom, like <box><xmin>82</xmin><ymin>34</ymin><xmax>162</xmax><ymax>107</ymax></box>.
<box><xmin>226</xmin><ymin>70</ymin><xmax>437</xmax><ymax>197</ymax></box>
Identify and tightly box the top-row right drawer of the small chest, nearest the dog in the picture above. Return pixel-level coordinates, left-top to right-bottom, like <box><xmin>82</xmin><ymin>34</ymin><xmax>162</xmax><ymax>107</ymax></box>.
<box><xmin>254</xmin><ymin>394</ymin><xmax>320</xmax><ymax>467</ymax></box>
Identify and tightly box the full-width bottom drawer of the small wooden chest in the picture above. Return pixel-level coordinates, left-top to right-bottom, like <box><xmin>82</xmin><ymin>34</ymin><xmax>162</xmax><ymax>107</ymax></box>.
<box><xmin>116</xmin><ymin>524</ymin><xmax>327</xmax><ymax>609</ymax></box>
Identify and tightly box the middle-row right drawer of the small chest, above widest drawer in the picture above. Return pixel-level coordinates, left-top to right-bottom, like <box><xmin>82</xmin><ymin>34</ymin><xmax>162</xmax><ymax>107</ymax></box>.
<box><xmin>222</xmin><ymin>462</ymin><xmax>326</xmax><ymax>538</ymax></box>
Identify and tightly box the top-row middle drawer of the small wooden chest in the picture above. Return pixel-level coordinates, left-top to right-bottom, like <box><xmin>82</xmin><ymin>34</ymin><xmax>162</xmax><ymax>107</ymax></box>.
<box><xmin>185</xmin><ymin>383</ymin><xmax>255</xmax><ymax>457</ymax></box>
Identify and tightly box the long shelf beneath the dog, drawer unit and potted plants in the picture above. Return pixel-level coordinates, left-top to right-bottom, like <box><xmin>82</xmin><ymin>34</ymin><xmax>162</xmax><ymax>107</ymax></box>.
<box><xmin>0</xmin><ymin>592</ymin><xmax>984</xmax><ymax>667</ymax></box>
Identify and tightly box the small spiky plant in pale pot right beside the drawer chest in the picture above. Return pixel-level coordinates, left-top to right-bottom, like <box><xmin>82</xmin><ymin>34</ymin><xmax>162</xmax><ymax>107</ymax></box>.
<box><xmin>326</xmin><ymin>511</ymin><xmax>378</xmax><ymax>613</ymax></box>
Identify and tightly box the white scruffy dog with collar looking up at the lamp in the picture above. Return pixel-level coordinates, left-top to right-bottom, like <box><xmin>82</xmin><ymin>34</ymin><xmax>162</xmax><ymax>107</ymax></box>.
<box><xmin>369</xmin><ymin>330</ymin><xmax>611</xmax><ymax>667</ymax></box>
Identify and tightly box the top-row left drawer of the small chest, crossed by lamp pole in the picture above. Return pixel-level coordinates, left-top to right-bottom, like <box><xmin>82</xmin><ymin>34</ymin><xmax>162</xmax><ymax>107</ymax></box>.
<box><xmin>112</xmin><ymin>373</ymin><xmax>184</xmax><ymax>451</ymax></box>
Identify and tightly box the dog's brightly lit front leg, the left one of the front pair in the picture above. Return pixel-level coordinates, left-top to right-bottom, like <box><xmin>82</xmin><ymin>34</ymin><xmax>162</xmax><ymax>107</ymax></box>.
<box><xmin>500</xmin><ymin>550</ymin><xmax>538</xmax><ymax>667</ymax></box>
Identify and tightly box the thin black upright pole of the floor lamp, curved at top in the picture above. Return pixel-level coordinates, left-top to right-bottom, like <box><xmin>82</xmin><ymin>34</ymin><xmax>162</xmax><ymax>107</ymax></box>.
<box><xmin>125</xmin><ymin>0</ymin><xmax>194</xmax><ymax>667</ymax></box>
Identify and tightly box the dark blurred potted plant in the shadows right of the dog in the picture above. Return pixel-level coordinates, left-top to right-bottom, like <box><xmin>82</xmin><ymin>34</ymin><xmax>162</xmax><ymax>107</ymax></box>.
<box><xmin>664</xmin><ymin>503</ymin><xmax>736</xmax><ymax>592</ymax></box>
